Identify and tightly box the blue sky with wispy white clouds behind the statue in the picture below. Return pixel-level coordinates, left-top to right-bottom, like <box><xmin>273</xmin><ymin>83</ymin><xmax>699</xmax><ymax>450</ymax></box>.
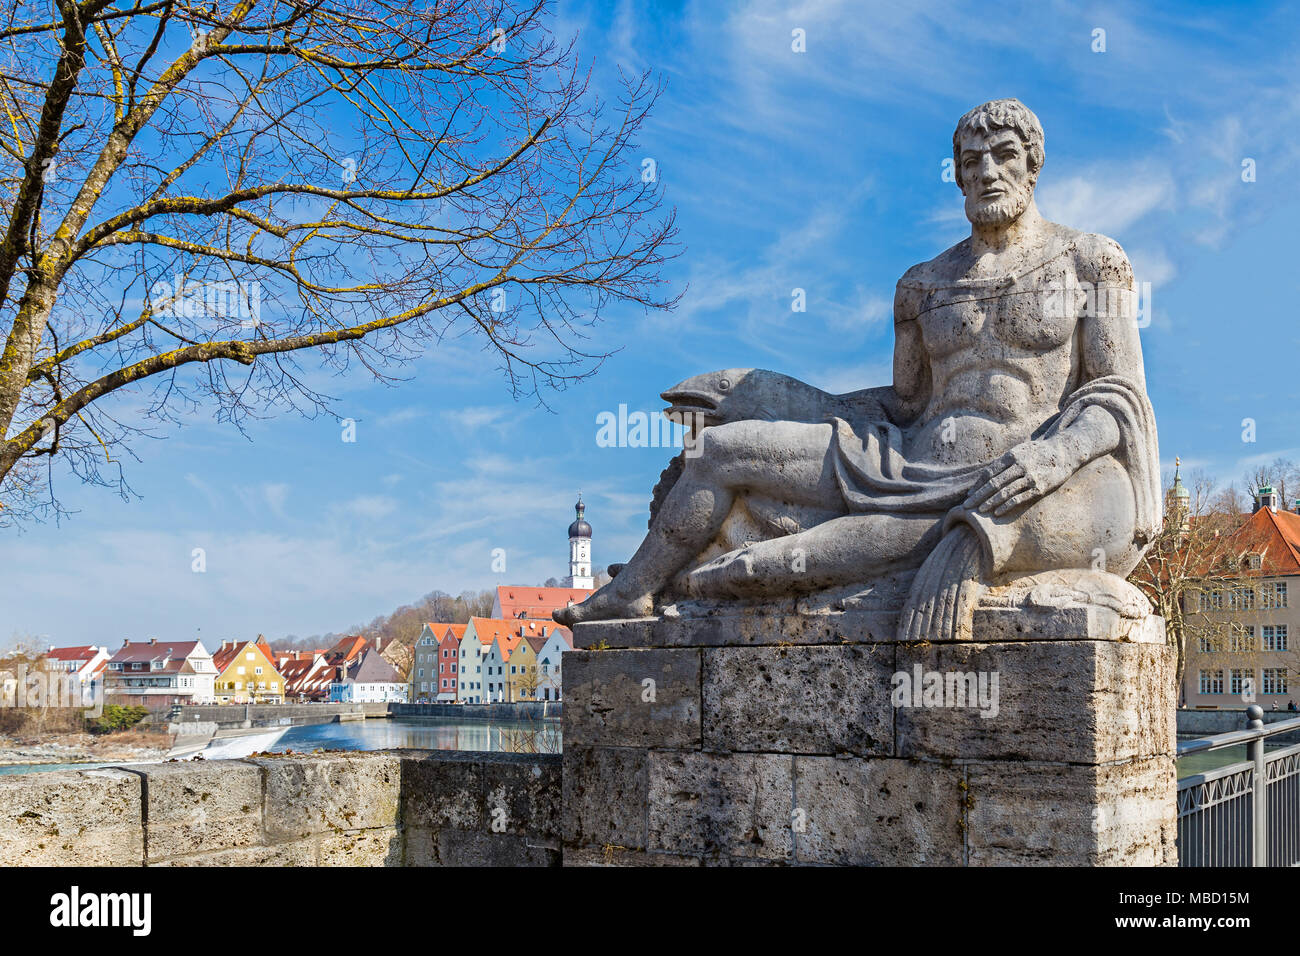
<box><xmin>0</xmin><ymin>1</ymin><xmax>1300</xmax><ymax>646</ymax></box>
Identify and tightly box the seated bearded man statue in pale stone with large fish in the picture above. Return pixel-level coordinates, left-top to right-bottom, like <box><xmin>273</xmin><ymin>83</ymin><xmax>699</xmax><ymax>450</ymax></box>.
<box><xmin>555</xmin><ymin>99</ymin><xmax>1160</xmax><ymax>640</ymax></box>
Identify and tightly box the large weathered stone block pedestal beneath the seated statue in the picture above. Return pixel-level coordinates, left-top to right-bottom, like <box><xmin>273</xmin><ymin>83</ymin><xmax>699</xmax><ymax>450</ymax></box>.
<box><xmin>563</xmin><ymin>605</ymin><xmax>1175</xmax><ymax>866</ymax></box>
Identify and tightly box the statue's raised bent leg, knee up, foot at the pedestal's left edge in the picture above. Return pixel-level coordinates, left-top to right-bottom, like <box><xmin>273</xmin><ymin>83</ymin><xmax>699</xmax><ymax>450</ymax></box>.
<box><xmin>555</xmin><ymin>421</ymin><xmax>842</xmax><ymax>624</ymax></box>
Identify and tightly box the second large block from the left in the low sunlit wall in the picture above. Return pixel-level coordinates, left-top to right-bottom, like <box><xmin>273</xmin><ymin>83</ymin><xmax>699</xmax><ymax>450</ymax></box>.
<box><xmin>133</xmin><ymin>760</ymin><xmax>263</xmax><ymax>862</ymax></box>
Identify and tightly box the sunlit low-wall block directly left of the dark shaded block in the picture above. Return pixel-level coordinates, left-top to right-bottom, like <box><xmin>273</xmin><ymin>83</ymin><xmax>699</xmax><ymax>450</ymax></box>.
<box><xmin>248</xmin><ymin>750</ymin><xmax>402</xmax><ymax>843</ymax></box>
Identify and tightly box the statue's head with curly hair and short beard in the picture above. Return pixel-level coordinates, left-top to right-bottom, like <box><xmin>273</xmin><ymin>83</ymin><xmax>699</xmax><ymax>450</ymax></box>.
<box><xmin>953</xmin><ymin>99</ymin><xmax>1045</xmax><ymax>226</ymax></box>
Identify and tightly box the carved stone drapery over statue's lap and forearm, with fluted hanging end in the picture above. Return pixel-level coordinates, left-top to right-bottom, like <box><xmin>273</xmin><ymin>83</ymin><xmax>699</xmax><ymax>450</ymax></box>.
<box><xmin>831</xmin><ymin>375</ymin><xmax>1161</xmax><ymax>640</ymax></box>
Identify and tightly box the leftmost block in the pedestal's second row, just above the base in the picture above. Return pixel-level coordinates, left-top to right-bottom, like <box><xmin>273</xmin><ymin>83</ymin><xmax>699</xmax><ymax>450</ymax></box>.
<box><xmin>562</xmin><ymin>747</ymin><xmax>649</xmax><ymax>849</ymax></box>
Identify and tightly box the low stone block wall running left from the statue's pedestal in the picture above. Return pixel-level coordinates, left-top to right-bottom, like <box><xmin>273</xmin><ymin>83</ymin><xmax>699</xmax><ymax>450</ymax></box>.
<box><xmin>0</xmin><ymin>750</ymin><xmax>560</xmax><ymax>866</ymax></box>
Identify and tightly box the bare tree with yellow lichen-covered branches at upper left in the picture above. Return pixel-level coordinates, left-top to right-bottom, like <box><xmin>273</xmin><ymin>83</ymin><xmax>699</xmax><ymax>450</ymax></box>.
<box><xmin>0</xmin><ymin>0</ymin><xmax>676</xmax><ymax>522</ymax></box>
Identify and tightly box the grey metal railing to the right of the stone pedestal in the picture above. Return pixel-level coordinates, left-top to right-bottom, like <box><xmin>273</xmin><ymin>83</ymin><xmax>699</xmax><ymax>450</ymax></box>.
<box><xmin>1178</xmin><ymin>704</ymin><xmax>1300</xmax><ymax>866</ymax></box>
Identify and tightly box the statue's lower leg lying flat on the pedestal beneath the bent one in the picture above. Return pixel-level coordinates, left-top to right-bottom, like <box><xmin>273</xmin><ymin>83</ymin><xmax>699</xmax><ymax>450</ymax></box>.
<box><xmin>684</xmin><ymin>514</ymin><xmax>943</xmax><ymax>598</ymax></box>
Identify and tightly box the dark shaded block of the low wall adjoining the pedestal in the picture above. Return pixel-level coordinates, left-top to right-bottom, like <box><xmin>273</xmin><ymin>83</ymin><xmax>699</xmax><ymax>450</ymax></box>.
<box><xmin>400</xmin><ymin>749</ymin><xmax>568</xmax><ymax>839</ymax></box>
